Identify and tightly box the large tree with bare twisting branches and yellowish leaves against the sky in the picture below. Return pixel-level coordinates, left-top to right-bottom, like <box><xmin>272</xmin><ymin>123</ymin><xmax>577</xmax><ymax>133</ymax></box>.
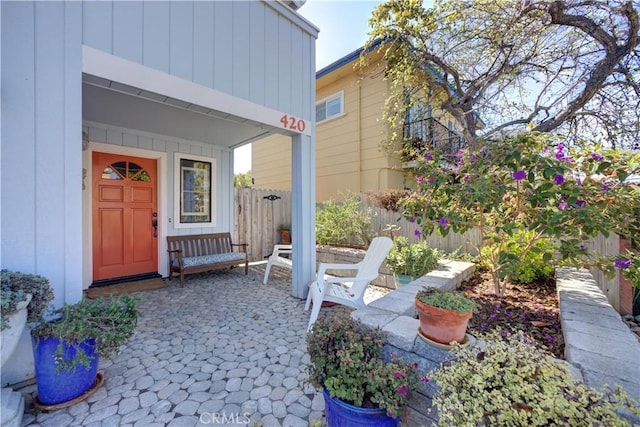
<box><xmin>363</xmin><ymin>0</ymin><xmax>640</xmax><ymax>149</ymax></box>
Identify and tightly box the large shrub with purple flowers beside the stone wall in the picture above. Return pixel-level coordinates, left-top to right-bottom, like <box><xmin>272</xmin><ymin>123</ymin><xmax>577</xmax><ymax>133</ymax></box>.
<box><xmin>403</xmin><ymin>133</ymin><xmax>640</xmax><ymax>295</ymax></box>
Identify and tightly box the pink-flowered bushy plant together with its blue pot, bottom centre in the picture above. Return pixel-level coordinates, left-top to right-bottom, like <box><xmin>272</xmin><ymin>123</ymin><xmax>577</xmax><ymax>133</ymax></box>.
<box><xmin>307</xmin><ymin>318</ymin><xmax>418</xmax><ymax>427</ymax></box>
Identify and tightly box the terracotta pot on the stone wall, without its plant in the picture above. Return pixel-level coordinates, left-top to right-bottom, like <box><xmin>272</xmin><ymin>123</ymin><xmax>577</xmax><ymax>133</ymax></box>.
<box><xmin>415</xmin><ymin>298</ymin><xmax>473</xmax><ymax>344</ymax></box>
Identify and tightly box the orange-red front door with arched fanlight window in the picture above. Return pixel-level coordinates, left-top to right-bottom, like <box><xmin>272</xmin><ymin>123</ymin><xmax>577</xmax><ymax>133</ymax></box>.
<box><xmin>92</xmin><ymin>152</ymin><xmax>158</xmax><ymax>281</ymax></box>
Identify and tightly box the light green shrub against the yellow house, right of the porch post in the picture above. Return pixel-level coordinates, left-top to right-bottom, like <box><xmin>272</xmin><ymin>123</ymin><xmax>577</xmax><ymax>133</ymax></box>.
<box><xmin>316</xmin><ymin>193</ymin><xmax>374</xmax><ymax>247</ymax></box>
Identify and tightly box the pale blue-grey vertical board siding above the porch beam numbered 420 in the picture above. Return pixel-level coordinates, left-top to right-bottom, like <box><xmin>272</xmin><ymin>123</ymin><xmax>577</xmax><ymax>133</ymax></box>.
<box><xmin>82</xmin><ymin>1</ymin><xmax>317</xmax><ymax>120</ymax></box>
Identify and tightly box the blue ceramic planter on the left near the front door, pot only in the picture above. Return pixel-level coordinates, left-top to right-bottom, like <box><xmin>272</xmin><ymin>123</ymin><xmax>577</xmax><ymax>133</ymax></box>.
<box><xmin>31</xmin><ymin>337</ymin><xmax>98</xmax><ymax>405</ymax></box>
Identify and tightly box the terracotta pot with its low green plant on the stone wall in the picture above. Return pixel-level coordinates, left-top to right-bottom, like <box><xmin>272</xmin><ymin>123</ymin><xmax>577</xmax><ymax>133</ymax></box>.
<box><xmin>415</xmin><ymin>288</ymin><xmax>475</xmax><ymax>345</ymax></box>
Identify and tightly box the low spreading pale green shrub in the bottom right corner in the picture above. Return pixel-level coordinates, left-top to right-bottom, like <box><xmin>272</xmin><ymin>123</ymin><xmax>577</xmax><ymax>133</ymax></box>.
<box><xmin>430</xmin><ymin>331</ymin><xmax>640</xmax><ymax>427</ymax></box>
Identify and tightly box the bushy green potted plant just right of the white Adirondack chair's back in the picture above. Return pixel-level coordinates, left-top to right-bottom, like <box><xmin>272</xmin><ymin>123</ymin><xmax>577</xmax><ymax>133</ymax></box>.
<box><xmin>386</xmin><ymin>236</ymin><xmax>438</xmax><ymax>287</ymax></box>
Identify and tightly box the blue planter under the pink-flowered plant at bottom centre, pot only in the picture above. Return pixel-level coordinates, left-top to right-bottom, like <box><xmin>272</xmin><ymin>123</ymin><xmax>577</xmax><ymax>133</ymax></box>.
<box><xmin>323</xmin><ymin>388</ymin><xmax>400</xmax><ymax>427</ymax></box>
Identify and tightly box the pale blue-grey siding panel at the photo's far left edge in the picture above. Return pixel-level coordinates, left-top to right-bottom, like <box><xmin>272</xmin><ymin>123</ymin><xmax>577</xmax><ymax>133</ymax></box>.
<box><xmin>0</xmin><ymin>2</ymin><xmax>36</xmax><ymax>272</ymax></box>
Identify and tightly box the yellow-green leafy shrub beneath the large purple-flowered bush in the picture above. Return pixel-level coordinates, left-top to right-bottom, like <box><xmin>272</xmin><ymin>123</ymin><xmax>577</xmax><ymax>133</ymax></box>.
<box><xmin>481</xmin><ymin>230</ymin><xmax>557</xmax><ymax>284</ymax></box>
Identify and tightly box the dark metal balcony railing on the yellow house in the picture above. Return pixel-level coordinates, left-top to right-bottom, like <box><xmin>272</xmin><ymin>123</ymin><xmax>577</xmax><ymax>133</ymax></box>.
<box><xmin>402</xmin><ymin>117</ymin><xmax>467</xmax><ymax>161</ymax></box>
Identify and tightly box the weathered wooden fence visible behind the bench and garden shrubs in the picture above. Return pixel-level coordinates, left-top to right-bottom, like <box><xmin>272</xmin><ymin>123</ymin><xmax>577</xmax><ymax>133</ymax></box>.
<box><xmin>234</xmin><ymin>188</ymin><xmax>620</xmax><ymax>310</ymax></box>
